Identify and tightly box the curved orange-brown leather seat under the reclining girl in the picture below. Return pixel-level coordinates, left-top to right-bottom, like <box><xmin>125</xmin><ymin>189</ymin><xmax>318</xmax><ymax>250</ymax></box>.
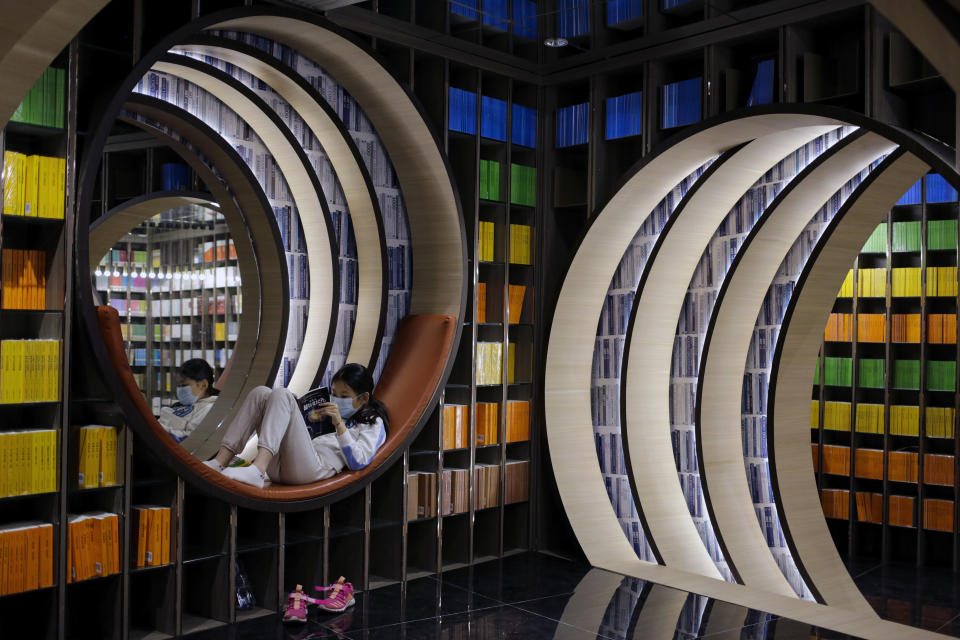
<box><xmin>97</xmin><ymin>306</ymin><xmax>456</xmax><ymax>501</ymax></box>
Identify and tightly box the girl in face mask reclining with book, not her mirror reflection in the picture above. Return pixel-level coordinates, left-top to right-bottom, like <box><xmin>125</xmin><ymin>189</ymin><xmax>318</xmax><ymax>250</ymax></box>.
<box><xmin>204</xmin><ymin>364</ymin><xmax>388</xmax><ymax>488</ymax></box>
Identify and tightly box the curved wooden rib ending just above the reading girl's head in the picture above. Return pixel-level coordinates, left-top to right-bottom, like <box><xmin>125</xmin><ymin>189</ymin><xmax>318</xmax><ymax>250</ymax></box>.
<box><xmin>171</xmin><ymin>36</ymin><xmax>387</xmax><ymax>368</ymax></box>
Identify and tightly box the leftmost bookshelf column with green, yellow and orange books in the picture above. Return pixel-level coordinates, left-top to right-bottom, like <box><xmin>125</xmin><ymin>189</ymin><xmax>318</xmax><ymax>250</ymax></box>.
<box><xmin>0</xmin><ymin>47</ymin><xmax>73</xmax><ymax>637</ymax></box>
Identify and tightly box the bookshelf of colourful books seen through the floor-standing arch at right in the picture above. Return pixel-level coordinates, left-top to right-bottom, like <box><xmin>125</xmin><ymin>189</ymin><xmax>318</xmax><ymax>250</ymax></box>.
<box><xmin>811</xmin><ymin>173</ymin><xmax>960</xmax><ymax>566</ymax></box>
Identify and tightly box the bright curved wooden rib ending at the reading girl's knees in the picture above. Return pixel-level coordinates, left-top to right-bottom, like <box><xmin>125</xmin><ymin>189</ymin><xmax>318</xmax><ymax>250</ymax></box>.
<box><xmin>153</xmin><ymin>55</ymin><xmax>340</xmax><ymax>396</ymax></box>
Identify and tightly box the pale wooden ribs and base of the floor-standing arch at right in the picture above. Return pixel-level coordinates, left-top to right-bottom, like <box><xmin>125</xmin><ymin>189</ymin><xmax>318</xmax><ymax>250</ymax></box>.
<box><xmin>544</xmin><ymin>105</ymin><xmax>960</xmax><ymax>638</ymax></box>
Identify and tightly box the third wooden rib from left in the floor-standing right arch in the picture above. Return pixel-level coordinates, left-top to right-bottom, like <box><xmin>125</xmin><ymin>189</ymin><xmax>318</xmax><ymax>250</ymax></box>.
<box><xmin>696</xmin><ymin>130</ymin><xmax>896</xmax><ymax>595</ymax></box>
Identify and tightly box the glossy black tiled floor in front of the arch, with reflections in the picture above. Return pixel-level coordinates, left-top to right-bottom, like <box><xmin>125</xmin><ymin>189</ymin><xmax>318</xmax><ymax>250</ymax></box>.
<box><xmin>180</xmin><ymin>553</ymin><xmax>876</xmax><ymax>640</ymax></box>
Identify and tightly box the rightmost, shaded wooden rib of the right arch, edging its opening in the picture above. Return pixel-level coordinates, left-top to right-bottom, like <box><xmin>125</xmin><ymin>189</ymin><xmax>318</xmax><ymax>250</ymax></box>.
<box><xmin>767</xmin><ymin>152</ymin><xmax>930</xmax><ymax>612</ymax></box>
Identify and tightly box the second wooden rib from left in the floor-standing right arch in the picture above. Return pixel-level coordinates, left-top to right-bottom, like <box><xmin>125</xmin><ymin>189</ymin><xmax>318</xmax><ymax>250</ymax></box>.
<box><xmin>620</xmin><ymin>121</ymin><xmax>838</xmax><ymax>580</ymax></box>
